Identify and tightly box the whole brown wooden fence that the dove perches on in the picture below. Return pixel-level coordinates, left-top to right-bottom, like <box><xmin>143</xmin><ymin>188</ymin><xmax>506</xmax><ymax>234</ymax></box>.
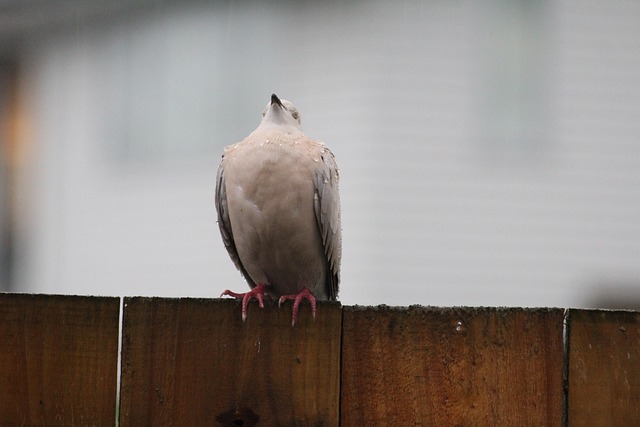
<box><xmin>0</xmin><ymin>294</ymin><xmax>640</xmax><ymax>426</ymax></box>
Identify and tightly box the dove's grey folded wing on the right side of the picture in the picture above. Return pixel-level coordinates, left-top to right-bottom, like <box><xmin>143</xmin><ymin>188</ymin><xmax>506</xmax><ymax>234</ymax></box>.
<box><xmin>313</xmin><ymin>148</ymin><xmax>342</xmax><ymax>300</ymax></box>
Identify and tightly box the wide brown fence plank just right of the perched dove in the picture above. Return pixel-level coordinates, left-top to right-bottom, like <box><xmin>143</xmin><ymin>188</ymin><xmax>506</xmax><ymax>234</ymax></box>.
<box><xmin>341</xmin><ymin>307</ymin><xmax>563</xmax><ymax>426</ymax></box>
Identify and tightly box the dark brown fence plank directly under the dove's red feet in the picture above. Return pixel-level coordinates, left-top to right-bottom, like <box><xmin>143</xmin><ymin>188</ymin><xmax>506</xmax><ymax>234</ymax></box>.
<box><xmin>120</xmin><ymin>298</ymin><xmax>341</xmax><ymax>427</ymax></box>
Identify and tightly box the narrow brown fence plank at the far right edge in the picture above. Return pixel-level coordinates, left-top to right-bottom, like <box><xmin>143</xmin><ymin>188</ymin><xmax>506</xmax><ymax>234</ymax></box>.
<box><xmin>568</xmin><ymin>310</ymin><xmax>640</xmax><ymax>426</ymax></box>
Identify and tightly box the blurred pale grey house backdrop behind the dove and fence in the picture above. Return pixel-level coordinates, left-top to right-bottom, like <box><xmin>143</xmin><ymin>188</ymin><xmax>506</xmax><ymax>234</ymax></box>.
<box><xmin>0</xmin><ymin>0</ymin><xmax>640</xmax><ymax>308</ymax></box>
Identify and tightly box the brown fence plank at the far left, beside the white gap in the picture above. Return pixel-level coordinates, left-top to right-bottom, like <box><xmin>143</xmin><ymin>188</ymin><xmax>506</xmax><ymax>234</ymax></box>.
<box><xmin>0</xmin><ymin>294</ymin><xmax>120</xmax><ymax>426</ymax></box>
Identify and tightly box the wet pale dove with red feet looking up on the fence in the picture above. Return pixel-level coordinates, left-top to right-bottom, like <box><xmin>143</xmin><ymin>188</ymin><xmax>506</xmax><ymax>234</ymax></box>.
<box><xmin>215</xmin><ymin>94</ymin><xmax>342</xmax><ymax>326</ymax></box>
